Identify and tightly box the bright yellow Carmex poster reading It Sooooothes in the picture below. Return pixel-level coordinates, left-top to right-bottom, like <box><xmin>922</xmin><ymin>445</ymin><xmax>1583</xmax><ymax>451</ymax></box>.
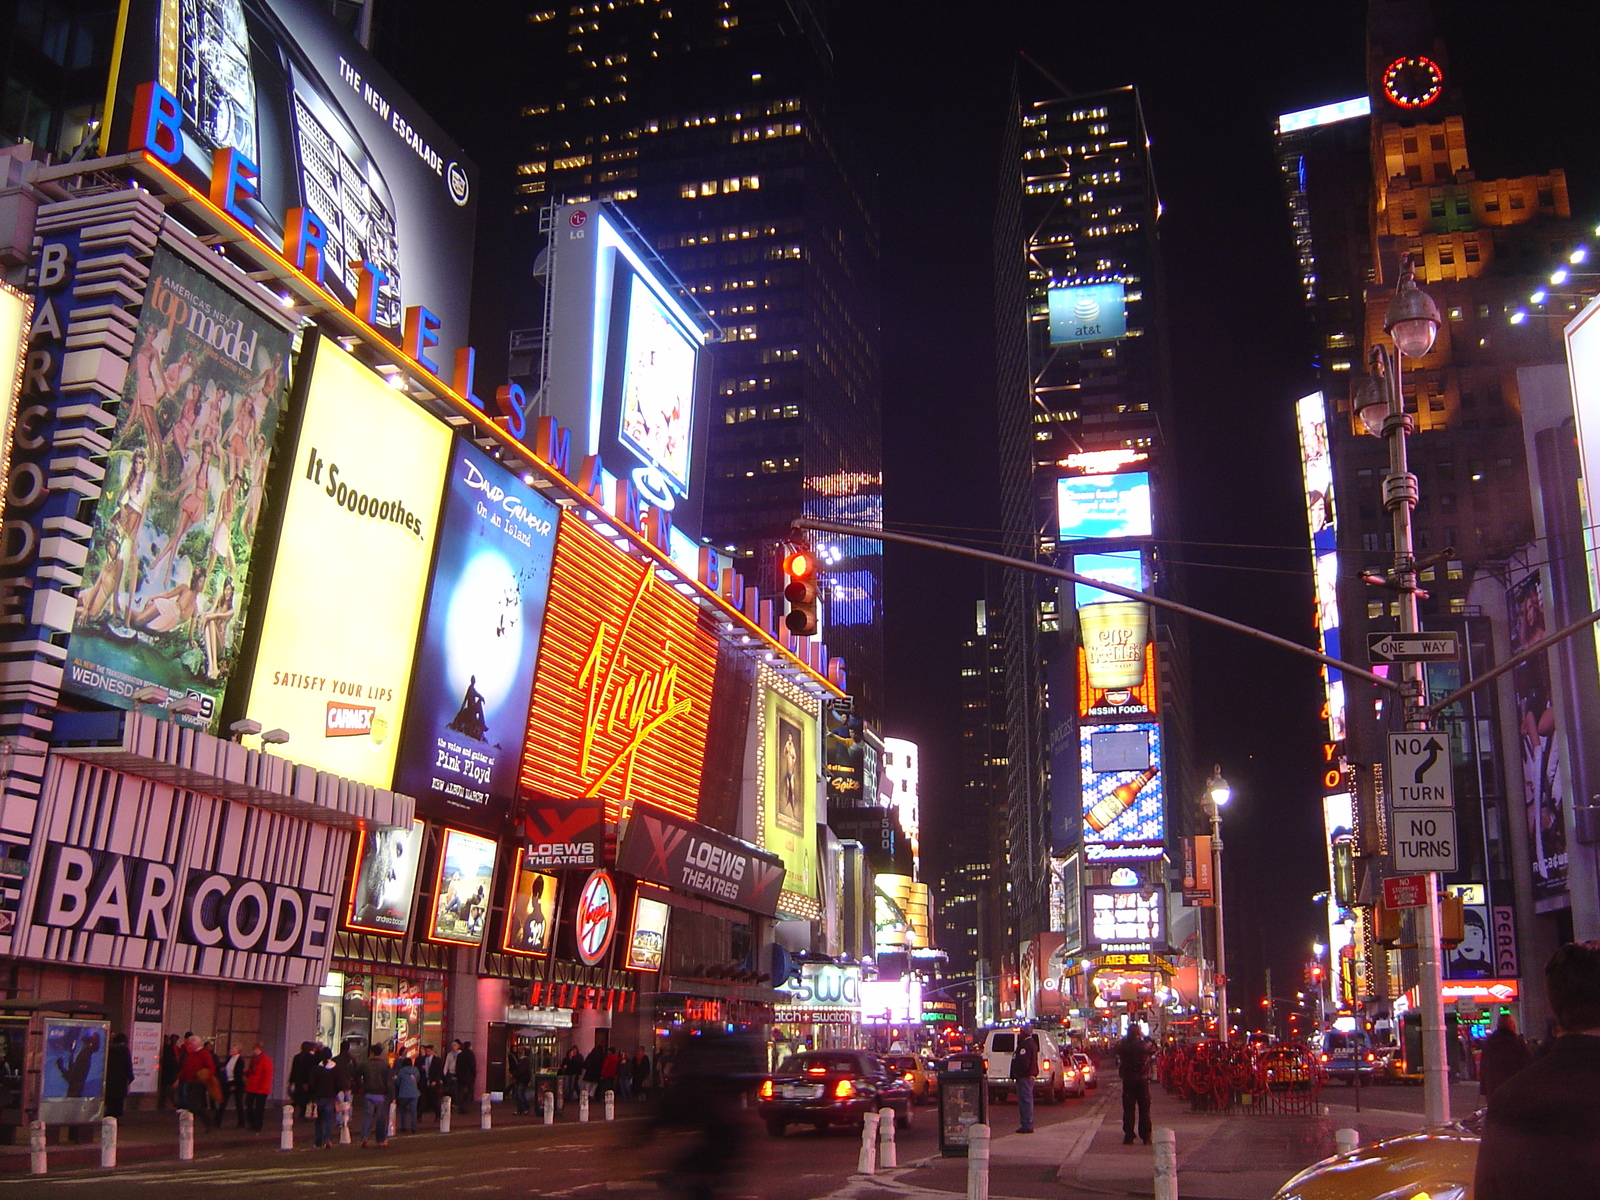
<box><xmin>246</xmin><ymin>341</ymin><xmax>450</xmax><ymax>787</ymax></box>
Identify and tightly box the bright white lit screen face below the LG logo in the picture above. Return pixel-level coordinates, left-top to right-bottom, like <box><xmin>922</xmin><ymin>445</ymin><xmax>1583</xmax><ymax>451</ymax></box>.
<box><xmin>618</xmin><ymin>275</ymin><xmax>694</xmax><ymax>496</ymax></box>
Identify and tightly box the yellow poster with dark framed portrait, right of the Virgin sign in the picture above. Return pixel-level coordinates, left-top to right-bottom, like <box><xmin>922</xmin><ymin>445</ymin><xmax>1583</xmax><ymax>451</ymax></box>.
<box><xmin>760</xmin><ymin>683</ymin><xmax>818</xmax><ymax>901</ymax></box>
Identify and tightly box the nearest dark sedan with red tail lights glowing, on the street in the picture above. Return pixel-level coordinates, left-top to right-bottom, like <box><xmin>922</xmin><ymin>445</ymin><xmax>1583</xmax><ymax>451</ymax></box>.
<box><xmin>755</xmin><ymin>1050</ymin><xmax>915</xmax><ymax>1138</ymax></box>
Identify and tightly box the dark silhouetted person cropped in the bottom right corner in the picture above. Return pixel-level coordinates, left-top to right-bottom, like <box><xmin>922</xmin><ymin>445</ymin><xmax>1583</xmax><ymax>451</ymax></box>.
<box><xmin>1472</xmin><ymin>942</ymin><xmax>1600</xmax><ymax>1200</ymax></box>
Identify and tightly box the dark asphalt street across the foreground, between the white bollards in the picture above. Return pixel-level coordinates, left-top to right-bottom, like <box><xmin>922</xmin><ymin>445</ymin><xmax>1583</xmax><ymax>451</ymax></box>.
<box><xmin>0</xmin><ymin>1093</ymin><xmax>1093</xmax><ymax>1200</ymax></box>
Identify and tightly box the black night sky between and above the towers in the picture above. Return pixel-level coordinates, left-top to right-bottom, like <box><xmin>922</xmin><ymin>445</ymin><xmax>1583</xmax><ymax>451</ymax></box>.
<box><xmin>387</xmin><ymin>0</ymin><xmax>1600</xmax><ymax>1021</ymax></box>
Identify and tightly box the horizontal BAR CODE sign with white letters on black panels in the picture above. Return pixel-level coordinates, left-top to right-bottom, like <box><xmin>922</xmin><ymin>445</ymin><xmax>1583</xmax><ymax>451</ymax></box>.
<box><xmin>34</xmin><ymin>846</ymin><xmax>334</xmax><ymax>960</ymax></box>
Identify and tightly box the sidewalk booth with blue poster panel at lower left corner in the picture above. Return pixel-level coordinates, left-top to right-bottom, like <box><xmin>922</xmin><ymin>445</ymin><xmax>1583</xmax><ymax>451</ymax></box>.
<box><xmin>0</xmin><ymin>1000</ymin><xmax>110</xmax><ymax>1142</ymax></box>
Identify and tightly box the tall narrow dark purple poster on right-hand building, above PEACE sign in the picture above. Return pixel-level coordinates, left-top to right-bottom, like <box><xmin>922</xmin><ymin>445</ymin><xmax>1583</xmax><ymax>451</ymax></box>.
<box><xmin>1507</xmin><ymin>571</ymin><xmax>1566</xmax><ymax>912</ymax></box>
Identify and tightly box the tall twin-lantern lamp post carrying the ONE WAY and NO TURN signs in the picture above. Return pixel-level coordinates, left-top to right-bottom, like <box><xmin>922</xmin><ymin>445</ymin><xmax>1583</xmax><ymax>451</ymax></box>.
<box><xmin>1355</xmin><ymin>253</ymin><xmax>1450</xmax><ymax>1125</ymax></box>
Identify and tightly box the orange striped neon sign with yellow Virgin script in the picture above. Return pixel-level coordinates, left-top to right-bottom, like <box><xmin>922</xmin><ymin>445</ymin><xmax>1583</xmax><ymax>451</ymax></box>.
<box><xmin>522</xmin><ymin>512</ymin><xmax>717</xmax><ymax>822</ymax></box>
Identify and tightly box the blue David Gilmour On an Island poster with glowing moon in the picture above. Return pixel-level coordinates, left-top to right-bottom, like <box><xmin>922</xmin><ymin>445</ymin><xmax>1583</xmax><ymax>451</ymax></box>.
<box><xmin>395</xmin><ymin>440</ymin><xmax>560</xmax><ymax>834</ymax></box>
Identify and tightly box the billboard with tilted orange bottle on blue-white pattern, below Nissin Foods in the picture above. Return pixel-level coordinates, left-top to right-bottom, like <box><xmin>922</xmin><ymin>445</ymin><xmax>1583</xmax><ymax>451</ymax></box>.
<box><xmin>1078</xmin><ymin>722</ymin><xmax>1166</xmax><ymax>862</ymax></box>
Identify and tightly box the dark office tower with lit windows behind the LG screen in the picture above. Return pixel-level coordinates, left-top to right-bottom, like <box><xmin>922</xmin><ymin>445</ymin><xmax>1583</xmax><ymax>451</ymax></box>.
<box><xmin>507</xmin><ymin>0</ymin><xmax>883</xmax><ymax>720</ymax></box>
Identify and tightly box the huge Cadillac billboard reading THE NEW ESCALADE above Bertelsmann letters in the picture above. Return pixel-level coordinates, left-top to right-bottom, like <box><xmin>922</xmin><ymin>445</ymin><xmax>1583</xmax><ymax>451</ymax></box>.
<box><xmin>101</xmin><ymin>0</ymin><xmax>478</xmax><ymax>363</ymax></box>
